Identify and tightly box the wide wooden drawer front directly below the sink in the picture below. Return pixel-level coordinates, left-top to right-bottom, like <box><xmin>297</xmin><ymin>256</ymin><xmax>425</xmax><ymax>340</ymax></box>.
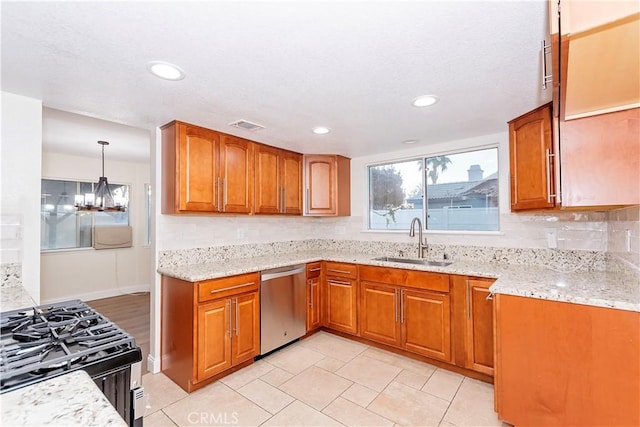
<box><xmin>360</xmin><ymin>265</ymin><xmax>449</xmax><ymax>292</ymax></box>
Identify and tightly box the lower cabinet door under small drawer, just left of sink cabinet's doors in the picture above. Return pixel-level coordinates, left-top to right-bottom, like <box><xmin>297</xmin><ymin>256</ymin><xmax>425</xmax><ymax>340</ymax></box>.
<box><xmin>326</xmin><ymin>277</ymin><xmax>358</xmax><ymax>334</ymax></box>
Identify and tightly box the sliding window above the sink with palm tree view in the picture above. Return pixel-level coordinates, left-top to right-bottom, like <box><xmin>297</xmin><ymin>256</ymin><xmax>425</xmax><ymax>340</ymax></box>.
<box><xmin>368</xmin><ymin>147</ymin><xmax>499</xmax><ymax>231</ymax></box>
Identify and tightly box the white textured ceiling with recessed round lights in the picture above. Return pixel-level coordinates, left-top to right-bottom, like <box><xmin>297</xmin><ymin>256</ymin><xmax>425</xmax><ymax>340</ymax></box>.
<box><xmin>1</xmin><ymin>0</ymin><xmax>551</xmax><ymax>161</ymax></box>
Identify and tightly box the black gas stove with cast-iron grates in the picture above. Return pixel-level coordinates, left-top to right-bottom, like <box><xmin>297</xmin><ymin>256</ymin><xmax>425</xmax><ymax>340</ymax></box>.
<box><xmin>0</xmin><ymin>300</ymin><xmax>142</xmax><ymax>425</ymax></box>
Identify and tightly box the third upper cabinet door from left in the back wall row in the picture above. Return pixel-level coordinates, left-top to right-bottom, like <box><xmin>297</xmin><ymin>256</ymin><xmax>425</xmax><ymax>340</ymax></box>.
<box><xmin>255</xmin><ymin>144</ymin><xmax>282</xmax><ymax>214</ymax></box>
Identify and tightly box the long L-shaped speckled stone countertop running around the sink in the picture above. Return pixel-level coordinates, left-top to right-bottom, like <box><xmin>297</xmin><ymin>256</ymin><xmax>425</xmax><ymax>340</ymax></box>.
<box><xmin>158</xmin><ymin>251</ymin><xmax>640</xmax><ymax>312</ymax></box>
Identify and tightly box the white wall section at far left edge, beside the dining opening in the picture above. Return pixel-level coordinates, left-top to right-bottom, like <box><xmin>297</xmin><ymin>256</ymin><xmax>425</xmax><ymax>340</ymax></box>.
<box><xmin>0</xmin><ymin>92</ymin><xmax>42</xmax><ymax>303</ymax></box>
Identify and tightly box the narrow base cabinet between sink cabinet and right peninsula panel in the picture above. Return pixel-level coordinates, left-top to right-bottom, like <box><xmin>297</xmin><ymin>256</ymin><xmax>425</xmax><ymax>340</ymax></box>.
<box><xmin>451</xmin><ymin>275</ymin><xmax>495</xmax><ymax>376</ymax></box>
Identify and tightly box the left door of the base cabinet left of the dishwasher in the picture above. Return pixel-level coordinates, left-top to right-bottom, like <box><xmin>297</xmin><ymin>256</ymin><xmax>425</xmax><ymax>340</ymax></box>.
<box><xmin>196</xmin><ymin>299</ymin><xmax>231</xmax><ymax>381</ymax></box>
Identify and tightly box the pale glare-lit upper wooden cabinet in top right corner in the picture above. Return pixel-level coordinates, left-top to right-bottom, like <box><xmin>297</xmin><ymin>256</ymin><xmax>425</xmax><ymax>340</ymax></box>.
<box><xmin>549</xmin><ymin>0</ymin><xmax>640</xmax><ymax>120</ymax></box>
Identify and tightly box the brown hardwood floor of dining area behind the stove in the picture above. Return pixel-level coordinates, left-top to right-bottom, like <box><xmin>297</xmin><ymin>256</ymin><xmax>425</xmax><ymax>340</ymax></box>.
<box><xmin>87</xmin><ymin>292</ymin><xmax>150</xmax><ymax>372</ymax></box>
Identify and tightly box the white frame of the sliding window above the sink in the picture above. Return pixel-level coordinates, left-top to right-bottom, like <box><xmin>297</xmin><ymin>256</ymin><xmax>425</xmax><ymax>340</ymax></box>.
<box><xmin>362</xmin><ymin>141</ymin><xmax>504</xmax><ymax>236</ymax></box>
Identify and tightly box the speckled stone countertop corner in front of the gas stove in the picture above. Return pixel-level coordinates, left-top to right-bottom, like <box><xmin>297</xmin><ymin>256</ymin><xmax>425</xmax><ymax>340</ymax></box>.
<box><xmin>0</xmin><ymin>370</ymin><xmax>127</xmax><ymax>427</ymax></box>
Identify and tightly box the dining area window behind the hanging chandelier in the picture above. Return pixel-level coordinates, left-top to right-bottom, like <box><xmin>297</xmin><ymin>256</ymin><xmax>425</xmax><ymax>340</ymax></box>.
<box><xmin>40</xmin><ymin>179</ymin><xmax>129</xmax><ymax>251</ymax></box>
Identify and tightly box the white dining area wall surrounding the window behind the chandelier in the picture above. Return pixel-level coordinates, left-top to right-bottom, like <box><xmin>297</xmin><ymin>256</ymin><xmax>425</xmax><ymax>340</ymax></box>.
<box><xmin>38</xmin><ymin>152</ymin><xmax>153</xmax><ymax>302</ymax></box>
